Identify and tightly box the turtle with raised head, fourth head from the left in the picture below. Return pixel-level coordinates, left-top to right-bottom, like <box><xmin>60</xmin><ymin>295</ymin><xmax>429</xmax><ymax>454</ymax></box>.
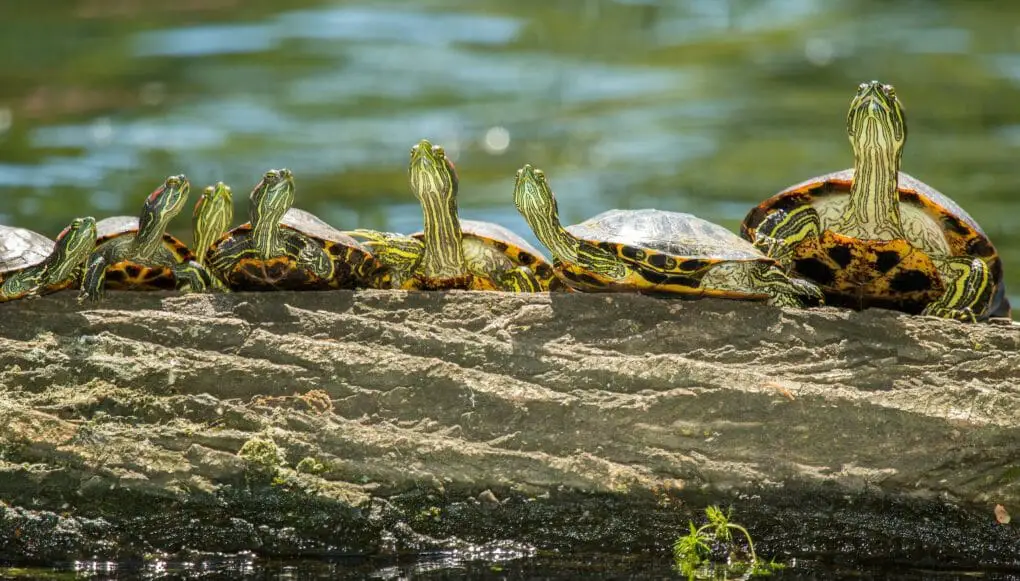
<box><xmin>205</xmin><ymin>168</ymin><xmax>390</xmax><ymax>291</ymax></box>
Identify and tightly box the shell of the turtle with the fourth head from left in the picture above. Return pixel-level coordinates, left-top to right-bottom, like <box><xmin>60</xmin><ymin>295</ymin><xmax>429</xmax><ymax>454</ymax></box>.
<box><xmin>206</xmin><ymin>208</ymin><xmax>390</xmax><ymax>291</ymax></box>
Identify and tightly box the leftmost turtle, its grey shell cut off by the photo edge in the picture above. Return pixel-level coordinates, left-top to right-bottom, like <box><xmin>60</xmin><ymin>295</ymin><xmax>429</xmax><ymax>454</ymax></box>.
<box><xmin>0</xmin><ymin>216</ymin><xmax>96</xmax><ymax>303</ymax></box>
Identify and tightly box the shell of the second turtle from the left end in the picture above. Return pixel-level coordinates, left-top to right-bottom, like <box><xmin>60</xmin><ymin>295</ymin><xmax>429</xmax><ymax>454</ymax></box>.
<box><xmin>96</xmin><ymin>216</ymin><xmax>195</xmax><ymax>291</ymax></box>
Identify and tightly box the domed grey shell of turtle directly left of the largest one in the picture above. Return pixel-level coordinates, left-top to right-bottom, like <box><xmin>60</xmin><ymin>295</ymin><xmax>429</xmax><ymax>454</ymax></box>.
<box><xmin>556</xmin><ymin>209</ymin><xmax>778</xmax><ymax>299</ymax></box>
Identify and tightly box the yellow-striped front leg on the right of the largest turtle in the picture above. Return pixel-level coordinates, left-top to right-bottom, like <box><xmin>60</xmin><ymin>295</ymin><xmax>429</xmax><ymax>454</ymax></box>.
<box><xmin>921</xmin><ymin>257</ymin><xmax>992</xmax><ymax>322</ymax></box>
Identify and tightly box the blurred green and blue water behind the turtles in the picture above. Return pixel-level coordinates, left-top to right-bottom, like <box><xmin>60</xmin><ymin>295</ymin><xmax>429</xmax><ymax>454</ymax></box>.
<box><xmin>0</xmin><ymin>0</ymin><xmax>1020</xmax><ymax>302</ymax></box>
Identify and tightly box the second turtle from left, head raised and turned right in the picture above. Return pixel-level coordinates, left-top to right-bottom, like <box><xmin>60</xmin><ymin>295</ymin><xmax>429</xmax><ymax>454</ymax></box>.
<box><xmin>78</xmin><ymin>174</ymin><xmax>212</xmax><ymax>303</ymax></box>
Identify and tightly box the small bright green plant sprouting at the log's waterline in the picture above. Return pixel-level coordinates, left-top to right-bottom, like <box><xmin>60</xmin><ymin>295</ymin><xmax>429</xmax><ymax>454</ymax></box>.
<box><xmin>673</xmin><ymin>499</ymin><xmax>784</xmax><ymax>580</ymax></box>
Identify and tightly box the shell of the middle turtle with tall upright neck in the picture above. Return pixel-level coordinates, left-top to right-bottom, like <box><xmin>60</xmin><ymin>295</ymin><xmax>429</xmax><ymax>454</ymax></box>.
<box><xmin>411</xmin><ymin>218</ymin><xmax>572</xmax><ymax>293</ymax></box>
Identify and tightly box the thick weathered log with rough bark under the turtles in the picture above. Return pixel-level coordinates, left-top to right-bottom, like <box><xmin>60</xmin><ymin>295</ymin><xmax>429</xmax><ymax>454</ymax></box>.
<box><xmin>0</xmin><ymin>291</ymin><xmax>1020</xmax><ymax>567</ymax></box>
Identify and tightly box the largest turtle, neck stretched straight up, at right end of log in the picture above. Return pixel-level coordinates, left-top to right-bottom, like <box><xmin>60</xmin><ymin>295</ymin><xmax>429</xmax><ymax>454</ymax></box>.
<box><xmin>741</xmin><ymin>81</ymin><xmax>1011</xmax><ymax>322</ymax></box>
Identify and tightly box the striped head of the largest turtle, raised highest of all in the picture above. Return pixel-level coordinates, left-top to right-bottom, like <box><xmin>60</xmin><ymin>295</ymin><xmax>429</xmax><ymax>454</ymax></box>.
<box><xmin>847</xmin><ymin>81</ymin><xmax>907</xmax><ymax>156</ymax></box>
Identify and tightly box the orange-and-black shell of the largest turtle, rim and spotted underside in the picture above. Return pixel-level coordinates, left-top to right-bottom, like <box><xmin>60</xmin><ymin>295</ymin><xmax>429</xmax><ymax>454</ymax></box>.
<box><xmin>741</xmin><ymin>168</ymin><xmax>1010</xmax><ymax>317</ymax></box>
